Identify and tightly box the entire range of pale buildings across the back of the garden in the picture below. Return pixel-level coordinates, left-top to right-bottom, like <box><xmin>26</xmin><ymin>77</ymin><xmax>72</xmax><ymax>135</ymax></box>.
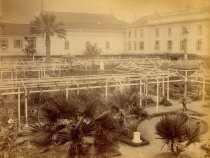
<box><xmin>0</xmin><ymin>9</ymin><xmax>210</xmax><ymax>56</ymax></box>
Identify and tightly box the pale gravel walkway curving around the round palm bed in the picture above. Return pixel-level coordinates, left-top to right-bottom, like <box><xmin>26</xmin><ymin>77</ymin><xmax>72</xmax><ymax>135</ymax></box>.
<box><xmin>120</xmin><ymin>101</ymin><xmax>210</xmax><ymax>158</ymax></box>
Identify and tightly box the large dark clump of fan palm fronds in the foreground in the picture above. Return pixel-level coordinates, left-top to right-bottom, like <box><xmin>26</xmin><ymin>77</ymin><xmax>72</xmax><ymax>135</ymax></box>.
<box><xmin>31</xmin><ymin>92</ymin><xmax>119</xmax><ymax>158</ymax></box>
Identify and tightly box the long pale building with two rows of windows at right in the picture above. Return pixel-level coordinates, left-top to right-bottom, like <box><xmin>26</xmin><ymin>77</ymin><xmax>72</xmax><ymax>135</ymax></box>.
<box><xmin>124</xmin><ymin>9</ymin><xmax>210</xmax><ymax>55</ymax></box>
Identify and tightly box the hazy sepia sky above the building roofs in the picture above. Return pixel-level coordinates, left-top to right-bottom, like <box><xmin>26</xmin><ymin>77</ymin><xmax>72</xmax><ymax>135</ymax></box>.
<box><xmin>0</xmin><ymin>0</ymin><xmax>210</xmax><ymax>23</ymax></box>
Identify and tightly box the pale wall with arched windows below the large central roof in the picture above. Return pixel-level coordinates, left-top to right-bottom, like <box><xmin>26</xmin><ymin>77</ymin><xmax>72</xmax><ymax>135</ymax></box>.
<box><xmin>51</xmin><ymin>30</ymin><xmax>124</xmax><ymax>55</ymax></box>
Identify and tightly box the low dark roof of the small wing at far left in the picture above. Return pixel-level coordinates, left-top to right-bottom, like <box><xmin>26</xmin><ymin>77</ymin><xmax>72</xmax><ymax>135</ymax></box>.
<box><xmin>0</xmin><ymin>23</ymin><xmax>30</xmax><ymax>35</ymax></box>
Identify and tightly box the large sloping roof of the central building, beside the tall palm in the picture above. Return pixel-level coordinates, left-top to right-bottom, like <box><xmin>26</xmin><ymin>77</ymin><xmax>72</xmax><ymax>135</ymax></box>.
<box><xmin>44</xmin><ymin>11</ymin><xmax>127</xmax><ymax>30</ymax></box>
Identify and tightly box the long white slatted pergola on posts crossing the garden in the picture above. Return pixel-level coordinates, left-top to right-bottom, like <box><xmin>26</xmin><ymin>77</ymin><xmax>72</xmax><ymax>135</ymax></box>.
<box><xmin>0</xmin><ymin>58</ymin><xmax>210</xmax><ymax>128</ymax></box>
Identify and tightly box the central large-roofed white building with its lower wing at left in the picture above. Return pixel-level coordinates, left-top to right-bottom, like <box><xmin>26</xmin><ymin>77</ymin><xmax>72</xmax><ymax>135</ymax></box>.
<box><xmin>0</xmin><ymin>12</ymin><xmax>126</xmax><ymax>56</ymax></box>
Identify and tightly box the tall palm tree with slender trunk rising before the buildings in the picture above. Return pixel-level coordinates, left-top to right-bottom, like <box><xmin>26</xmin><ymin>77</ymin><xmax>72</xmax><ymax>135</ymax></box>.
<box><xmin>30</xmin><ymin>13</ymin><xmax>65</xmax><ymax>62</ymax></box>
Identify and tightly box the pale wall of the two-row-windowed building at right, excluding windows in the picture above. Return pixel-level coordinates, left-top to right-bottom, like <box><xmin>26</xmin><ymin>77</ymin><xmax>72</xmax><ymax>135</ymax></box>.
<box><xmin>125</xmin><ymin>20</ymin><xmax>210</xmax><ymax>55</ymax></box>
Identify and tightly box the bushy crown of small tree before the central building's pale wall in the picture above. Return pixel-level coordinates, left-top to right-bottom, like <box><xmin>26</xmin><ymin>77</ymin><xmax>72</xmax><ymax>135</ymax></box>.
<box><xmin>83</xmin><ymin>44</ymin><xmax>101</xmax><ymax>59</ymax></box>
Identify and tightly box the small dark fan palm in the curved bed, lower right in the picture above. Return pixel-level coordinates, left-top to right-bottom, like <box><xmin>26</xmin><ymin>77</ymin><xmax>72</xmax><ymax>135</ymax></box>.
<box><xmin>156</xmin><ymin>113</ymin><xmax>201</xmax><ymax>156</ymax></box>
